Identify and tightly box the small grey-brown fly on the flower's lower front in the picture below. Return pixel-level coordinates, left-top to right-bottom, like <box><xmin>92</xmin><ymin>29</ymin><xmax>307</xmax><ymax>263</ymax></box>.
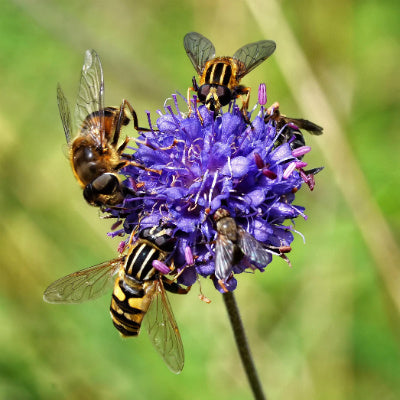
<box><xmin>213</xmin><ymin>208</ymin><xmax>291</xmax><ymax>287</ymax></box>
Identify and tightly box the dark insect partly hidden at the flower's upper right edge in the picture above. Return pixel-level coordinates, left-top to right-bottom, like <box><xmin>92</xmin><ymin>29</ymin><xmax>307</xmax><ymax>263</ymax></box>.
<box><xmin>264</xmin><ymin>102</ymin><xmax>323</xmax><ymax>150</ymax></box>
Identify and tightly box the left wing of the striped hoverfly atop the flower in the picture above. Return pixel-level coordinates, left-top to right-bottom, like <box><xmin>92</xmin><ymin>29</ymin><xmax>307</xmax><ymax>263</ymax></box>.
<box><xmin>183</xmin><ymin>32</ymin><xmax>215</xmax><ymax>75</ymax></box>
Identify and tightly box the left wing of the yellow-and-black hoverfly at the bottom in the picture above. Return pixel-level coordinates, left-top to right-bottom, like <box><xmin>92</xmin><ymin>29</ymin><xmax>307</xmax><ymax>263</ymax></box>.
<box><xmin>43</xmin><ymin>257</ymin><xmax>124</xmax><ymax>303</ymax></box>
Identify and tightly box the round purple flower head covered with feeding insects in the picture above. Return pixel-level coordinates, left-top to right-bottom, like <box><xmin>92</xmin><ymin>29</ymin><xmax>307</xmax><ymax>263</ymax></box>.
<box><xmin>110</xmin><ymin>95</ymin><xmax>318</xmax><ymax>291</ymax></box>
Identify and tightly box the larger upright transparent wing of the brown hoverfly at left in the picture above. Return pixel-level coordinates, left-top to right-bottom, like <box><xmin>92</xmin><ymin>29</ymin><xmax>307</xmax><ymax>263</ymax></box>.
<box><xmin>75</xmin><ymin>50</ymin><xmax>104</xmax><ymax>138</ymax></box>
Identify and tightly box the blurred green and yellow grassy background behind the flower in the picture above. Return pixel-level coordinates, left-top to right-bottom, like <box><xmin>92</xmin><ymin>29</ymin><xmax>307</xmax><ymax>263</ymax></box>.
<box><xmin>0</xmin><ymin>0</ymin><xmax>400</xmax><ymax>400</ymax></box>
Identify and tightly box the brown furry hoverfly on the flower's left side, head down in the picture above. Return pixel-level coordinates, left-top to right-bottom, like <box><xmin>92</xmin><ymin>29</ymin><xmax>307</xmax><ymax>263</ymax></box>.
<box><xmin>57</xmin><ymin>50</ymin><xmax>160</xmax><ymax>206</ymax></box>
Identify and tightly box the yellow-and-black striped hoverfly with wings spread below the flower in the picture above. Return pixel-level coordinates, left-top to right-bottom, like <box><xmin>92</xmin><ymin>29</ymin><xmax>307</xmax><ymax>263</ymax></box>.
<box><xmin>43</xmin><ymin>225</ymin><xmax>190</xmax><ymax>373</ymax></box>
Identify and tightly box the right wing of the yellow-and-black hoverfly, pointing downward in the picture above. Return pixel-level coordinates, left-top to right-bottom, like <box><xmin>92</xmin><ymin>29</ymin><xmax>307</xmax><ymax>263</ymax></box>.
<box><xmin>144</xmin><ymin>280</ymin><xmax>185</xmax><ymax>374</ymax></box>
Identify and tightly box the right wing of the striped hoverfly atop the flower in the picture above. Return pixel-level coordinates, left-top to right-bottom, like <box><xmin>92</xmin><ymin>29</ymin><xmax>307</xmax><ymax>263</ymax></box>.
<box><xmin>233</xmin><ymin>40</ymin><xmax>276</xmax><ymax>79</ymax></box>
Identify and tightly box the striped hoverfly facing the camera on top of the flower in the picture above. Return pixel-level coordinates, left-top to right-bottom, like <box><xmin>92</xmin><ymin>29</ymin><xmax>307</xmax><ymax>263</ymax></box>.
<box><xmin>183</xmin><ymin>32</ymin><xmax>276</xmax><ymax>119</ymax></box>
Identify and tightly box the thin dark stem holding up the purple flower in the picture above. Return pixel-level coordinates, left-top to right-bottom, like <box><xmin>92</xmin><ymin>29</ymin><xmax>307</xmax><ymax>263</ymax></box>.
<box><xmin>222</xmin><ymin>292</ymin><xmax>266</xmax><ymax>400</ymax></box>
